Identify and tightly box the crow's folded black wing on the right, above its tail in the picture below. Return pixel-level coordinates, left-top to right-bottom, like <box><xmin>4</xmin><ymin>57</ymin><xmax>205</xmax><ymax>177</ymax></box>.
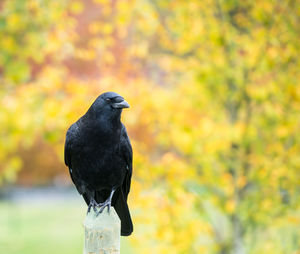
<box><xmin>120</xmin><ymin>125</ymin><xmax>132</xmax><ymax>197</ymax></box>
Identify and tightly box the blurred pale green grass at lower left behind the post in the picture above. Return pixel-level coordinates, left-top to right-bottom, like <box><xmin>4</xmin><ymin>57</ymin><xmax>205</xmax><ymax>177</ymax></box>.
<box><xmin>0</xmin><ymin>202</ymin><xmax>133</xmax><ymax>254</ymax></box>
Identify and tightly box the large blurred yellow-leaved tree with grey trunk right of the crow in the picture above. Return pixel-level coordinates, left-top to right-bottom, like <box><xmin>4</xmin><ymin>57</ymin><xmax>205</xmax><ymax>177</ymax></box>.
<box><xmin>122</xmin><ymin>1</ymin><xmax>300</xmax><ymax>253</ymax></box>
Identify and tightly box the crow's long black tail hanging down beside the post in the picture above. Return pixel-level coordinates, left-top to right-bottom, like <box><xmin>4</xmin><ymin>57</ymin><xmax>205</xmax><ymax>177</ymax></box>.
<box><xmin>112</xmin><ymin>188</ymin><xmax>133</xmax><ymax>236</ymax></box>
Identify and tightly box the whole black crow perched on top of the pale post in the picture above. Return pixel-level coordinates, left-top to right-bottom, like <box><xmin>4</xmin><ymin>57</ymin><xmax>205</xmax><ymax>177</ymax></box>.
<box><xmin>65</xmin><ymin>92</ymin><xmax>133</xmax><ymax>236</ymax></box>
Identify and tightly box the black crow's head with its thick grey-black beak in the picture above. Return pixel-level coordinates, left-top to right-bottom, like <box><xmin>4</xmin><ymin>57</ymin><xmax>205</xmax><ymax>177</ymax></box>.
<box><xmin>89</xmin><ymin>92</ymin><xmax>129</xmax><ymax>118</ymax></box>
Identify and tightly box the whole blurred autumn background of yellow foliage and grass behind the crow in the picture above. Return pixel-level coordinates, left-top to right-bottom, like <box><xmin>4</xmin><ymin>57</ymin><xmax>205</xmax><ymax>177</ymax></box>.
<box><xmin>0</xmin><ymin>0</ymin><xmax>300</xmax><ymax>254</ymax></box>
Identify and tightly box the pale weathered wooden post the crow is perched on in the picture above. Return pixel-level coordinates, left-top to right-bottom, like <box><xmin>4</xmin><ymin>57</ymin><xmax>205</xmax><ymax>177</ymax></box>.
<box><xmin>83</xmin><ymin>207</ymin><xmax>121</xmax><ymax>254</ymax></box>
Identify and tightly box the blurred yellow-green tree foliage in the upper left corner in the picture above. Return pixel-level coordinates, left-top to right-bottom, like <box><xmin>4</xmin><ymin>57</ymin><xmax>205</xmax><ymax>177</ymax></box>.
<box><xmin>0</xmin><ymin>0</ymin><xmax>72</xmax><ymax>182</ymax></box>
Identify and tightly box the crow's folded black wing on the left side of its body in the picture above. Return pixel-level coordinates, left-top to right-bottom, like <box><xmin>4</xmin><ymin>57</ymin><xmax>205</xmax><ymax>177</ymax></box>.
<box><xmin>64</xmin><ymin>123</ymin><xmax>84</xmax><ymax>194</ymax></box>
